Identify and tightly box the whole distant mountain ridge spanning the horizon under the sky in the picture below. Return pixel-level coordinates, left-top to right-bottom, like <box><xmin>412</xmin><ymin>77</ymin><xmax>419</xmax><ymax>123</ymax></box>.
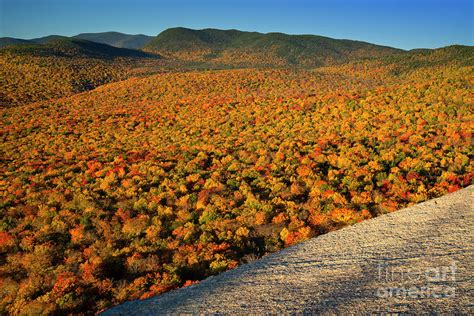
<box><xmin>0</xmin><ymin>27</ymin><xmax>473</xmax><ymax>68</ymax></box>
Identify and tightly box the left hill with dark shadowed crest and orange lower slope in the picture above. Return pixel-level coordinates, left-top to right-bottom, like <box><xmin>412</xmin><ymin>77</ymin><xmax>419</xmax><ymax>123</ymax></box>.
<box><xmin>0</xmin><ymin>38</ymin><xmax>159</xmax><ymax>107</ymax></box>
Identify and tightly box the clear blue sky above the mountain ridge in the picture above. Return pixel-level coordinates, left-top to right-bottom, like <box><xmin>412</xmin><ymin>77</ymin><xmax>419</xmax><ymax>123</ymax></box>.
<box><xmin>0</xmin><ymin>0</ymin><xmax>474</xmax><ymax>49</ymax></box>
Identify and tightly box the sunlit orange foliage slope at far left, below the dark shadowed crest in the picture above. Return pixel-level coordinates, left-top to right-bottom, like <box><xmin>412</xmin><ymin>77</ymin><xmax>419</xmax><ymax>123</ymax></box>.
<box><xmin>0</xmin><ymin>51</ymin><xmax>130</xmax><ymax>107</ymax></box>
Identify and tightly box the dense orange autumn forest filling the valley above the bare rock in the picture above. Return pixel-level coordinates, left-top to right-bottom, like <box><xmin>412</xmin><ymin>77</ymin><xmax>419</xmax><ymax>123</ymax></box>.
<box><xmin>0</xmin><ymin>42</ymin><xmax>474</xmax><ymax>314</ymax></box>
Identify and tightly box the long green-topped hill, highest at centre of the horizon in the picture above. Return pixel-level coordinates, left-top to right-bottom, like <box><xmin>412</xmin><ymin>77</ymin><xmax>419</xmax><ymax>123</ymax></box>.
<box><xmin>144</xmin><ymin>27</ymin><xmax>403</xmax><ymax>66</ymax></box>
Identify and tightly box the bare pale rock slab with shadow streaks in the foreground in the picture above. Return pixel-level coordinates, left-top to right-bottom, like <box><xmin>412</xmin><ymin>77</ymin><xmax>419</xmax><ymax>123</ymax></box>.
<box><xmin>103</xmin><ymin>186</ymin><xmax>474</xmax><ymax>315</ymax></box>
